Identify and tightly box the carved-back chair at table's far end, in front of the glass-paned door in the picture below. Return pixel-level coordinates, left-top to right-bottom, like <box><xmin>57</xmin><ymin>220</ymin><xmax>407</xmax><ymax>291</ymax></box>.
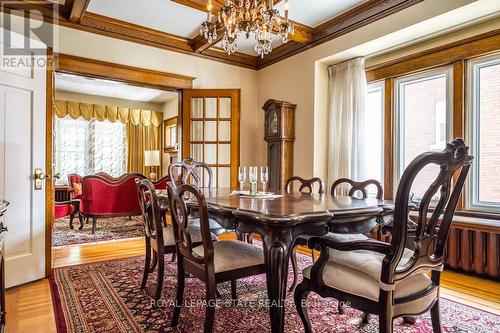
<box><xmin>168</xmin><ymin>157</ymin><xmax>228</xmax><ymax>236</ymax></box>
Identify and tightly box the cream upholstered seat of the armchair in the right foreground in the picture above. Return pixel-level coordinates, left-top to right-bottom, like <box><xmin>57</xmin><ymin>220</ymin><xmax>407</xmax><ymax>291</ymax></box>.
<box><xmin>302</xmin><ymin>249</ymin><xmax>432</xmax><ymax>301</ymax></box>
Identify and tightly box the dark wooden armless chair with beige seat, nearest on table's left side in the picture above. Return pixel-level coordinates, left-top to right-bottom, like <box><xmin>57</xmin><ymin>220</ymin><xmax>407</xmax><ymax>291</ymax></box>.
<box><xmin>168</xmin><ymin>184</ymin><xmax>265</xmax><ymax>333</ymax></box>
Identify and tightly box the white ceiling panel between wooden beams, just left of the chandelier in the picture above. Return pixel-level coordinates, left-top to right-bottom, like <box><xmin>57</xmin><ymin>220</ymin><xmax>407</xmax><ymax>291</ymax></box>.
<box><xmin>87</xmin><ymin>0</ymin><xmax>206</xmax><ymax>38</ymax></box>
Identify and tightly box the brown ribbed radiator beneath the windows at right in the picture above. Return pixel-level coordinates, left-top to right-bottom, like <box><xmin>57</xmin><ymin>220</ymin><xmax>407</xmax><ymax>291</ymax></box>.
<box><xmin>371</xmin><ymin>219</ymin><xmax>500</xmax><ymax>280</ymax></box>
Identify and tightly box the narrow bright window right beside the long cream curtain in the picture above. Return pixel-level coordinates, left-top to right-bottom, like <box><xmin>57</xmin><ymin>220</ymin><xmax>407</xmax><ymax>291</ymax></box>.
<box><xmin>364</xmin><ymin>82</ymin><xmax>384</xmax><ymax>189</ymax></box>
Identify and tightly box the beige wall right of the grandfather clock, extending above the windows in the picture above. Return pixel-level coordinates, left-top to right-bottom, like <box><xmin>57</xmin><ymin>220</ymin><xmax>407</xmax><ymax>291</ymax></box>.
<box><xmin>258</xmin><ymin>0</ymin><xmax>492</xmax><ymax>179</ymax></box>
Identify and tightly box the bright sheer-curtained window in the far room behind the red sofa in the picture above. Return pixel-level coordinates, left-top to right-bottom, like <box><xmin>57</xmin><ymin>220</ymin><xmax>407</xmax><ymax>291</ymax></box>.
<box><xmin>55</xmin><ymin>117</ymin><xmax>127</xmax><ymax>184</ymax></box>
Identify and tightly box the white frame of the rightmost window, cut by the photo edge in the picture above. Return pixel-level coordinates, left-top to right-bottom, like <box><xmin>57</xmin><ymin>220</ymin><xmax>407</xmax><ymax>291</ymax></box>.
<box><xmin>465</xmin><ymin>53</ymin><xmax>500</xmax><ymax>214</ymax></box>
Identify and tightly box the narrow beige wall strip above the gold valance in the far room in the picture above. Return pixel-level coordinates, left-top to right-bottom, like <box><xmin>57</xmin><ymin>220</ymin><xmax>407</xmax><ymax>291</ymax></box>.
<box><xmin>55</xmin><ymin>90</ymin><xmax>162</xmax><ymax>111</ymax></box>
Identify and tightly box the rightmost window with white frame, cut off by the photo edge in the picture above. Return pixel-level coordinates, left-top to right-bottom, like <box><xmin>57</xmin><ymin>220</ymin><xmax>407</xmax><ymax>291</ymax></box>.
<box><xmin>467</xmin><ymin>55</ymin><xmax>500</xmax><ymax>212</ymax></box>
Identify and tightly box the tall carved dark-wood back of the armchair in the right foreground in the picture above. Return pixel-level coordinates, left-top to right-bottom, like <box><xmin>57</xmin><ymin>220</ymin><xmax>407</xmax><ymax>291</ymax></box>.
<box><xmin>381</xmin><ymin>139</ymin><xmax>473</xmax><ymax>284</ymax></box>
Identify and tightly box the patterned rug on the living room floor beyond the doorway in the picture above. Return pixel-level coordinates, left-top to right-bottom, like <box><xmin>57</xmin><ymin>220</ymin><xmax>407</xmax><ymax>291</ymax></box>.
<box><xmin>52</xmin><ymin>216</ymin><xmax>144</xmax><ymax>246</ymax></box>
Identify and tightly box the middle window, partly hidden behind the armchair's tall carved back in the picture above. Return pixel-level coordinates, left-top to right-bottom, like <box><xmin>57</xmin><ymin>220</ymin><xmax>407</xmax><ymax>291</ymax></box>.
<box><xmin>394</xmin><ymin>68</ymin><xmax>453</xmax><ymax>201</ymax></box>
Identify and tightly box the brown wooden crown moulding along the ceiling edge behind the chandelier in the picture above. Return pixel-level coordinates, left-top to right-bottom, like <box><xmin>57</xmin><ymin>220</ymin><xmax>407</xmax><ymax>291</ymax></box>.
<box><xmin>0</xmin><ymin>0</ymin><xmax>423</xmax><ymax>70</ymax></box>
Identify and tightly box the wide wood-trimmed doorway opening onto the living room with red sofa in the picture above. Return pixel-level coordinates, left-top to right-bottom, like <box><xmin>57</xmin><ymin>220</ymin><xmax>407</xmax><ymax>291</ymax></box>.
<box><xmin>46</xmin><ymin>55</ymin><xmax>193</xmax><ymax>272</ymax></box>
